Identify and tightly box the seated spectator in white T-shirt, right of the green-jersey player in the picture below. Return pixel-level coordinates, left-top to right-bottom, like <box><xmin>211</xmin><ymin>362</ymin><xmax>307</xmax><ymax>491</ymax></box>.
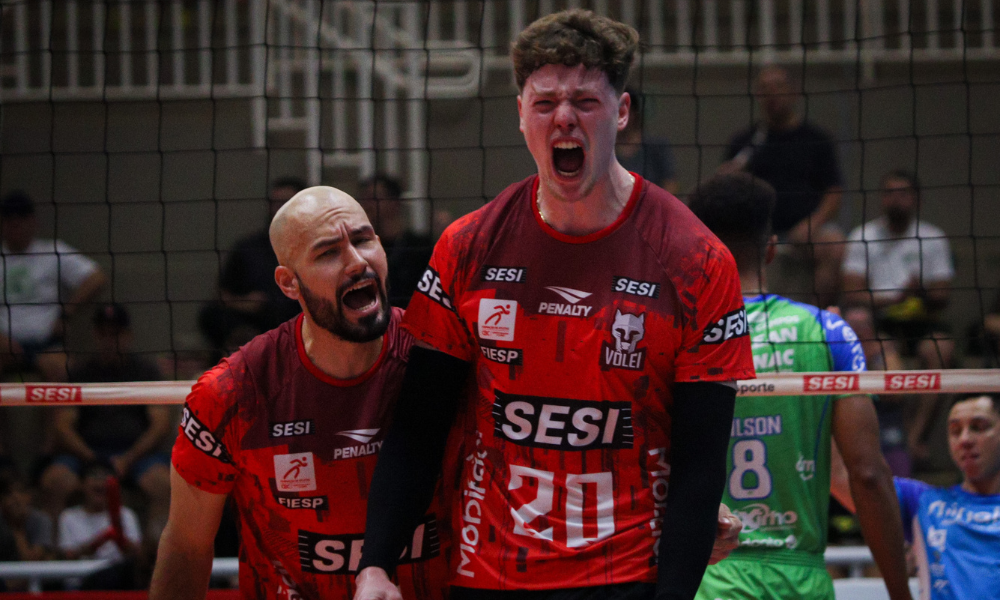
<box><xmin>843</xmin><ymin>170</ymin><xmax>955</xmax><ymax>458</ymax></box>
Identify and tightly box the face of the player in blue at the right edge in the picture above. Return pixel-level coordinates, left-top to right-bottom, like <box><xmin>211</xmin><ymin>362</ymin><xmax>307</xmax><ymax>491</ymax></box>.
<box><xmin>948</xmin><ymin>396</ymin><xmax>1000</xmax><ymax>482</ymax></box>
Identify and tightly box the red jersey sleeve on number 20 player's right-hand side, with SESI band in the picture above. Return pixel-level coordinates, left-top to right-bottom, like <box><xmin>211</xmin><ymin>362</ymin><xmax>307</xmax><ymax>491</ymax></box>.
<box><xmin>674</xmin><ymin>247</ymin><xmax>756</xmax><ymax>382</ymax></box>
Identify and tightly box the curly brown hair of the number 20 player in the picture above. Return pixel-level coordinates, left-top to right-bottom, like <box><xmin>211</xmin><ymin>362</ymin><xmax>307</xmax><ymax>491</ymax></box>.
<box><xmin>510</xmin><ymin>8</ymin><xmax>639</xmax><ymax>94</ymax></box>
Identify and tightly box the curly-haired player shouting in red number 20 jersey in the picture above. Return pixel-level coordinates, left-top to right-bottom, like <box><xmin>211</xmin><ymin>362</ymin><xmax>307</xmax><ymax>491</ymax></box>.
<box><xmin>355</xmin><ymin>10</ymin><xmax>754</xmax><ymax>600</ymax></box>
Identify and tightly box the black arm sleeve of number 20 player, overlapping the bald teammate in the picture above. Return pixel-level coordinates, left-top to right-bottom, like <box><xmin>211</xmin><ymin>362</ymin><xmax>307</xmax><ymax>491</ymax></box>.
<box><xmin>358</xmin><ymin>346</ymin><xmax>469</xmax><ymax>575</ymax></box>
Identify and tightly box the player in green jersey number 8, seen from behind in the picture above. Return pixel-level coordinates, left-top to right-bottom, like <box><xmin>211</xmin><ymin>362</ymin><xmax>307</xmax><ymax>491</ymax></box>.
<box><xmin>690</xmin><ymin>173</ymin><xmax>910</xmax><ymax>600</ymax></box>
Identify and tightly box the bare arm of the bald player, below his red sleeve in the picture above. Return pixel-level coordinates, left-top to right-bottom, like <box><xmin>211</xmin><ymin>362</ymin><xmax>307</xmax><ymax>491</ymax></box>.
<box><xmin>149</xmin><ymin>466</ymin><xmax>226</xmax><ymax>600</ymax></box>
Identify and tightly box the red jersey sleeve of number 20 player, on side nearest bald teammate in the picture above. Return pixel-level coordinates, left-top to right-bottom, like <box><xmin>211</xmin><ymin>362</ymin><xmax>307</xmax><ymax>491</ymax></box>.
<box><xmin>403</xmin><ymin>220</ymin><xmax>476</xmax><ymax>362</ymax></box>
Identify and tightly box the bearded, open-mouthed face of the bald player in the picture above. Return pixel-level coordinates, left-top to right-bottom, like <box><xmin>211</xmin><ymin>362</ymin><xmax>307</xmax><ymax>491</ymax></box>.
<box><xmin>295</xmin><ymin>204</ymin><xmax>391</xmax><ymax>343</ymax></box>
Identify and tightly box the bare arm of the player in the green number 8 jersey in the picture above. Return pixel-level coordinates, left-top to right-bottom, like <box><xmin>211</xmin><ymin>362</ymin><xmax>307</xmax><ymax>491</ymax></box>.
<box><xmin>831</xmin><ymin>396</ymin><xmax>910</xmax><ymax>600</ymax></box>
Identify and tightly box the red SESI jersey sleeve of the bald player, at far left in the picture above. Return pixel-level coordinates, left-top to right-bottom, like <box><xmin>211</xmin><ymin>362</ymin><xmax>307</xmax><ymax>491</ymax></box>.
<box><xmin>172</xmin><ymin>362</ymin><xmax>237</xmax><ymax>494</ymax></box>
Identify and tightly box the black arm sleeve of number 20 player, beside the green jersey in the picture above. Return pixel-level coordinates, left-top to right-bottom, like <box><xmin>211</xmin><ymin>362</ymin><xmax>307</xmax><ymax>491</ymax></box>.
<box><xmin>656</xmin><ymin>382</ymin><xmax>736</xmax><ymax>600</ymax></box>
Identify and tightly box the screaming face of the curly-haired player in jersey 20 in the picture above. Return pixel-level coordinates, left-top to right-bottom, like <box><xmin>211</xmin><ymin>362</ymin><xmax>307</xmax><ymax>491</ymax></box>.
<box><xmin>517</xmin><ymin>65</ymin><xmax>628</xmax><ymax>200</ymax></box>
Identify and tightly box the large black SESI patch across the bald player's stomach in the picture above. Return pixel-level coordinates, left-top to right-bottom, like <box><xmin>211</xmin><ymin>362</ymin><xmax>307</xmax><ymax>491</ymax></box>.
<box><xmin>299</xmin><ymin>514</ymin><xmax>441</xmax><ymax>575</ymax></box>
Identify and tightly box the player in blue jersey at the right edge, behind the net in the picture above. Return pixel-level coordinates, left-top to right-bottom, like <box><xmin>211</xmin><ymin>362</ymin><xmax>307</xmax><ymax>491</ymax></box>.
<box><xmin>832</xmin><ymin>394</ymin><xmax>1000</xmax><ymax>600</ymax></box>
